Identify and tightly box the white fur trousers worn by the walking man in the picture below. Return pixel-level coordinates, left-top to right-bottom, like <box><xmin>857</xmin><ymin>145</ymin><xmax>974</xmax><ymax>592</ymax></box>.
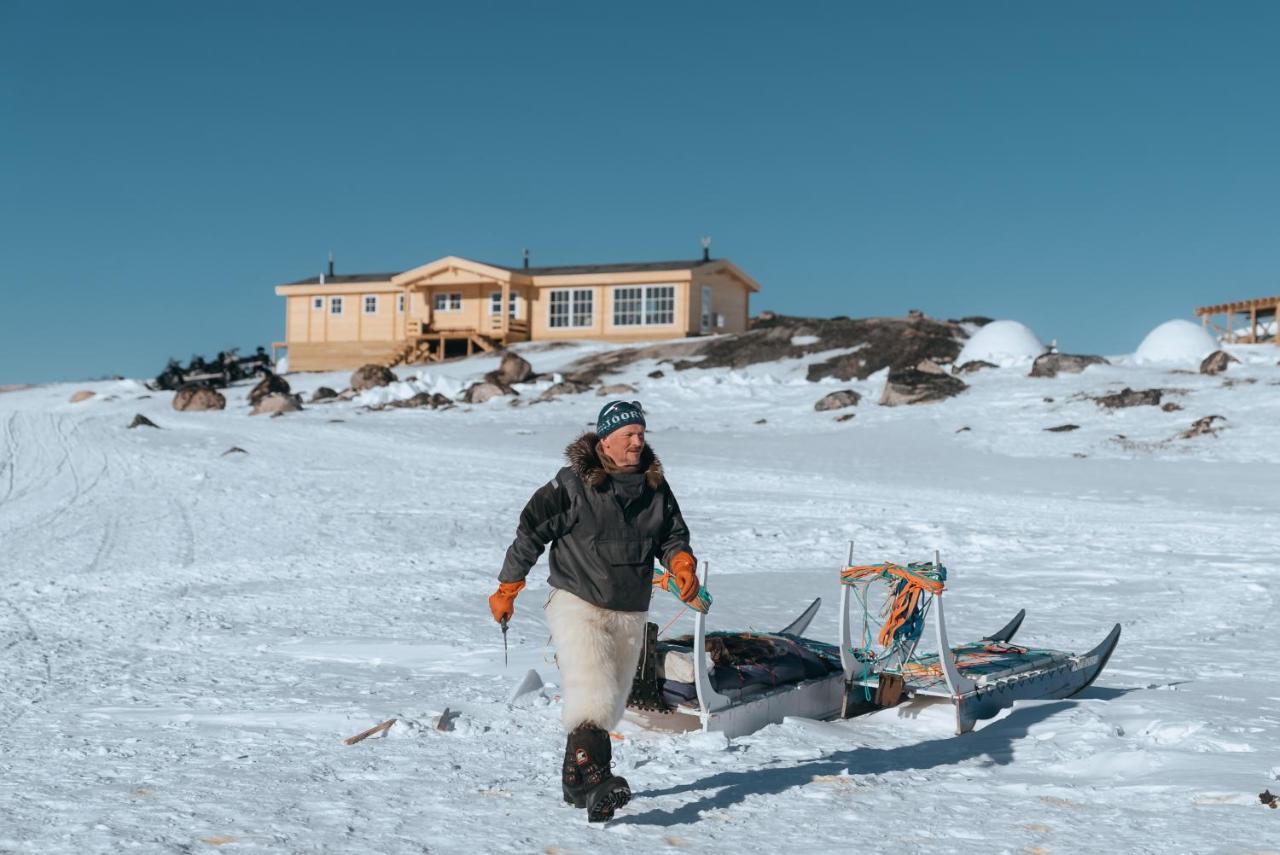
<box><xmin>547</xmin><ymin>589</ymin><xmax>649</xmax><ymax>731</ymax></box>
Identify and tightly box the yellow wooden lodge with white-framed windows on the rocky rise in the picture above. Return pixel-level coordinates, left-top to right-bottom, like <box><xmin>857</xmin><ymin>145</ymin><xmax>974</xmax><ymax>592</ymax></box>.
<box><xmin>273</xmin><ymin>250</ymin><xmax>760</xmax><ymax>371</ymax></box>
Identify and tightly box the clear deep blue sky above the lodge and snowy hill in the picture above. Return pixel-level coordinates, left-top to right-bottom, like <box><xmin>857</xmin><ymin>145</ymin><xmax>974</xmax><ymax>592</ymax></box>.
<box><xmin>0</xmin><ymin>0</ymin><xmax>1280</xmax><ymax>383</ymax></box>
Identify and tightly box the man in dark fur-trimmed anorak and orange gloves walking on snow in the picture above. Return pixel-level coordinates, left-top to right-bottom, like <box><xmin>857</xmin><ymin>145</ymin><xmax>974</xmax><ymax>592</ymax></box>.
<box><xmin>489</xmin><ymin>401</ymin><xmax>699</xmax><ymax>822</ymax></box>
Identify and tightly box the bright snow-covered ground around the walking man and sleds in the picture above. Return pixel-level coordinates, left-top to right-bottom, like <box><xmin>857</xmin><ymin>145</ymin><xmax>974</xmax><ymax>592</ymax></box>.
<box><xmin>0</xmin><ymin>346</ymin><xmax>1280</xmax><ymax>852</ymax></box>
